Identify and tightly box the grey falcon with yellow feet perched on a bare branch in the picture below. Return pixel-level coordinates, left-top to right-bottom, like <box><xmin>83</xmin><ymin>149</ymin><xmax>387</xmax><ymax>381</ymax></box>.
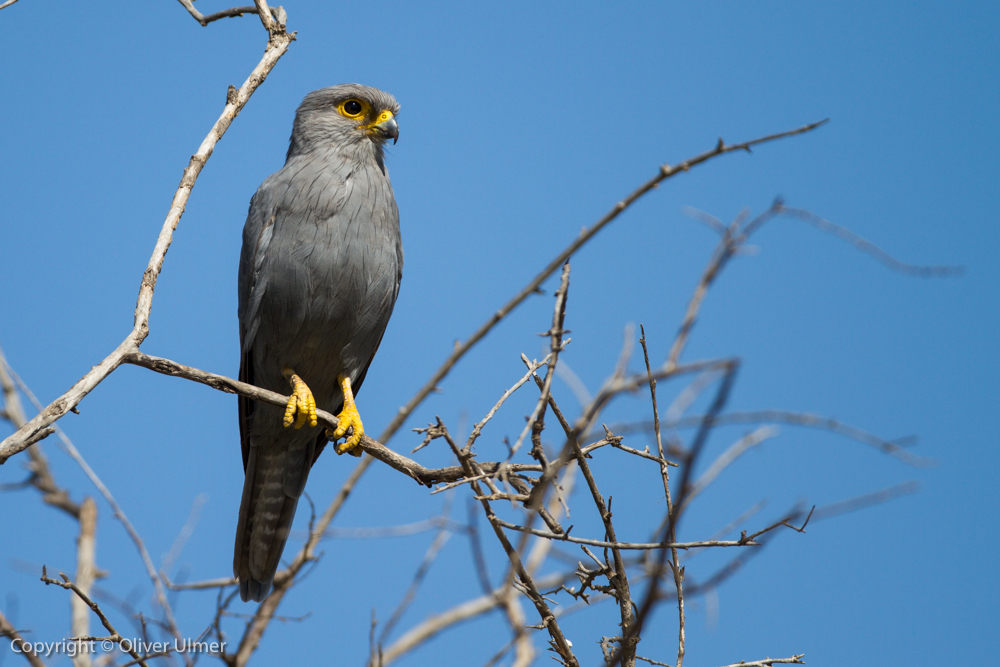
<box><xmin>233</xmin><ymin>84</ymin><xmax>403</xmax><ymax>602</ymax></box>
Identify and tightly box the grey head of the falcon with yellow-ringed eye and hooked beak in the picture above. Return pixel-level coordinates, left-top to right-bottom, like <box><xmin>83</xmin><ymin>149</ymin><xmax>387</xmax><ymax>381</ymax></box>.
<box><xmin>288</xmin><ymin>83</ymin><xmax>399</xmax><ymax>158</ymax></box>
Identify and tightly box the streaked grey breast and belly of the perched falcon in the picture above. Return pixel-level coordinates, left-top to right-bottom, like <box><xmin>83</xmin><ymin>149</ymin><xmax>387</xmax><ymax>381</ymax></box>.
<box><xmin>252</xmin><ymin>157</ymin><xmax>402</xmax><ymax>396</ymax></box>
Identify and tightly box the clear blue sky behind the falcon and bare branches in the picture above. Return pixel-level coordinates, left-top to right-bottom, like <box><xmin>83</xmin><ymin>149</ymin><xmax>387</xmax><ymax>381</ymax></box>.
<box><xmin>0</xmin><ymin>0</ymin><xmax>1000</xmax><ymax>667</ymax></box>
